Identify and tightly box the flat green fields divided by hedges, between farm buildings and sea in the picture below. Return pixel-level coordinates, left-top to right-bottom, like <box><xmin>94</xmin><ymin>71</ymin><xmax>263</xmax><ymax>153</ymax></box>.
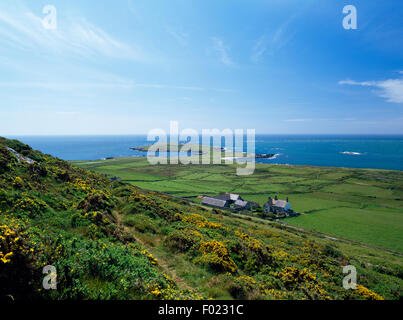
<box><xmin>74</xmin><ymin>158</ymin><xmax>403</xmax><ymax>252</ymax></box>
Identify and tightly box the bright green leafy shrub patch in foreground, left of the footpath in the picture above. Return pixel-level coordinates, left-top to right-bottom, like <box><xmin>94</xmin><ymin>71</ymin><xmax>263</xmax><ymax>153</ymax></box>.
<box><xmin>41</xmin><ymin>235</ymin><xmax>172</xmax><ymax>300</ymax></box>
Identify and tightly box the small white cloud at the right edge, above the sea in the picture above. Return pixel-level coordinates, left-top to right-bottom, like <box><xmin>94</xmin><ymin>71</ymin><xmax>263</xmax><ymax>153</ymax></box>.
<box><xmin>339</xmin><ymin>71</ymin><xmax>403</xmax><ymax>103</ymax></box>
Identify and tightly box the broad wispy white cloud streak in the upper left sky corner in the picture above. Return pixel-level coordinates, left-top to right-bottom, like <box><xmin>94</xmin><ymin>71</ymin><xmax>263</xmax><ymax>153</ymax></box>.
<box><xmin>0</xmin><ymin>6</ymin><xmax>144</xmax><ymax>60</ymax></box>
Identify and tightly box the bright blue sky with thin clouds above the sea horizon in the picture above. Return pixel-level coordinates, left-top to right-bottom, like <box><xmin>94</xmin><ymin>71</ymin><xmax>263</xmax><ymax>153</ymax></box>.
<box><xmin>0</xmin><ymin>0</ymin><xmax>403</xmax><ymax>135</ymax></box>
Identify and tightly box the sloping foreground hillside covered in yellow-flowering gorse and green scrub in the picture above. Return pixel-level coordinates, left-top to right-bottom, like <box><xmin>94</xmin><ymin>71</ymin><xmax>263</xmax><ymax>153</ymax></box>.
<box><xmin>0</xmin><ymin>139</ymin><xmax>403</xmax><ymax>299</ymax></box>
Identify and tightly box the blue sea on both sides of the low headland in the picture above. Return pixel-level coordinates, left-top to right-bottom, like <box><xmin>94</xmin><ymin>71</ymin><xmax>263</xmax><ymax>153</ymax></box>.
<box><xmin>7</xmin><ymin>135</ymin><xmax>403</xmax><ymax>170</ymax></box>
